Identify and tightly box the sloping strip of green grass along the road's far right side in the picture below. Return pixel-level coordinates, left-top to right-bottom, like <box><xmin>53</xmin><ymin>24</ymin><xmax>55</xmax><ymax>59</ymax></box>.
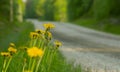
<box><xmin>74</xmin><ymin>18</ymin><xmax>120</xmax><ymax>35</ymax></box>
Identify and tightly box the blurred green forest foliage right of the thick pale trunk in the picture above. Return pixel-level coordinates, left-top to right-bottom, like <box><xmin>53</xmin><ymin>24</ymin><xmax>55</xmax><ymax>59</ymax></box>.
<box><xmin>23</xmin><ymin>0</ymin><xmax>120</xmax><ymax>21</ymax></box>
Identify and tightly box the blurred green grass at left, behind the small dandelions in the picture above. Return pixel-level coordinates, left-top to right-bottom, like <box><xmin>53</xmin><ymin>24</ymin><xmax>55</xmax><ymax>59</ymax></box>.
<box><xmin>0</xmin><ymin>22</ymin><xmax>34</xmax><ymax>50</ymax></box>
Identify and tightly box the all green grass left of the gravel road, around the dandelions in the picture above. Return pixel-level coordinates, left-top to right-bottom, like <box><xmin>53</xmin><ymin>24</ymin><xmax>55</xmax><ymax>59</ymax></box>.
<box><xmin>0</xmin><ymin>22</ymin><xmax>81</xmax><ymax>72</ymax></box>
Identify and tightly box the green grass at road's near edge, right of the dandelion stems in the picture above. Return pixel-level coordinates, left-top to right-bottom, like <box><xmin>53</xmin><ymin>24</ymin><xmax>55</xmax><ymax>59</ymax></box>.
<box><xmin>50</xmin><ymin>52</ymin><xmax>82</xmax><ymax>72</ymax></box>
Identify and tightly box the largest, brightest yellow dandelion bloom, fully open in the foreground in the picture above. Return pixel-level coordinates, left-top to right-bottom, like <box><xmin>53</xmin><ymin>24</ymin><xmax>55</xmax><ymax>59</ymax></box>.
<box><xmin>27</xmin><ymin>47</ymin><xmax>43</xmax><ymax>57</ymax></box>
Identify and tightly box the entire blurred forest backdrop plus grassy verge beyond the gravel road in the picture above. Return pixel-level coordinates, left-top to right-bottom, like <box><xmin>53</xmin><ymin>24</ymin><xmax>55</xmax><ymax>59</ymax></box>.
<box><xmin>0</xmin><ymin>0</ymin><xmax>120</xmax><ymax>34</ymax></box>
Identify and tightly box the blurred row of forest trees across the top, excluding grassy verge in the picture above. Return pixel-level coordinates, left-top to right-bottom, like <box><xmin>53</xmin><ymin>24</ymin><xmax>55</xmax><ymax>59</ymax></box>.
<box><xmin>0</xmin><ymin>0</ymin><xmax>120</xmax><ymax>21</ymax></box>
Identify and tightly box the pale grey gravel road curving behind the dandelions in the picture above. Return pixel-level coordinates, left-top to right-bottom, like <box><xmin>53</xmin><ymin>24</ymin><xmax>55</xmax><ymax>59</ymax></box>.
<box><xmin>29</xmin><ymin>19</ymin><xmax>120</xmax><ymax>72</ymax></box>
